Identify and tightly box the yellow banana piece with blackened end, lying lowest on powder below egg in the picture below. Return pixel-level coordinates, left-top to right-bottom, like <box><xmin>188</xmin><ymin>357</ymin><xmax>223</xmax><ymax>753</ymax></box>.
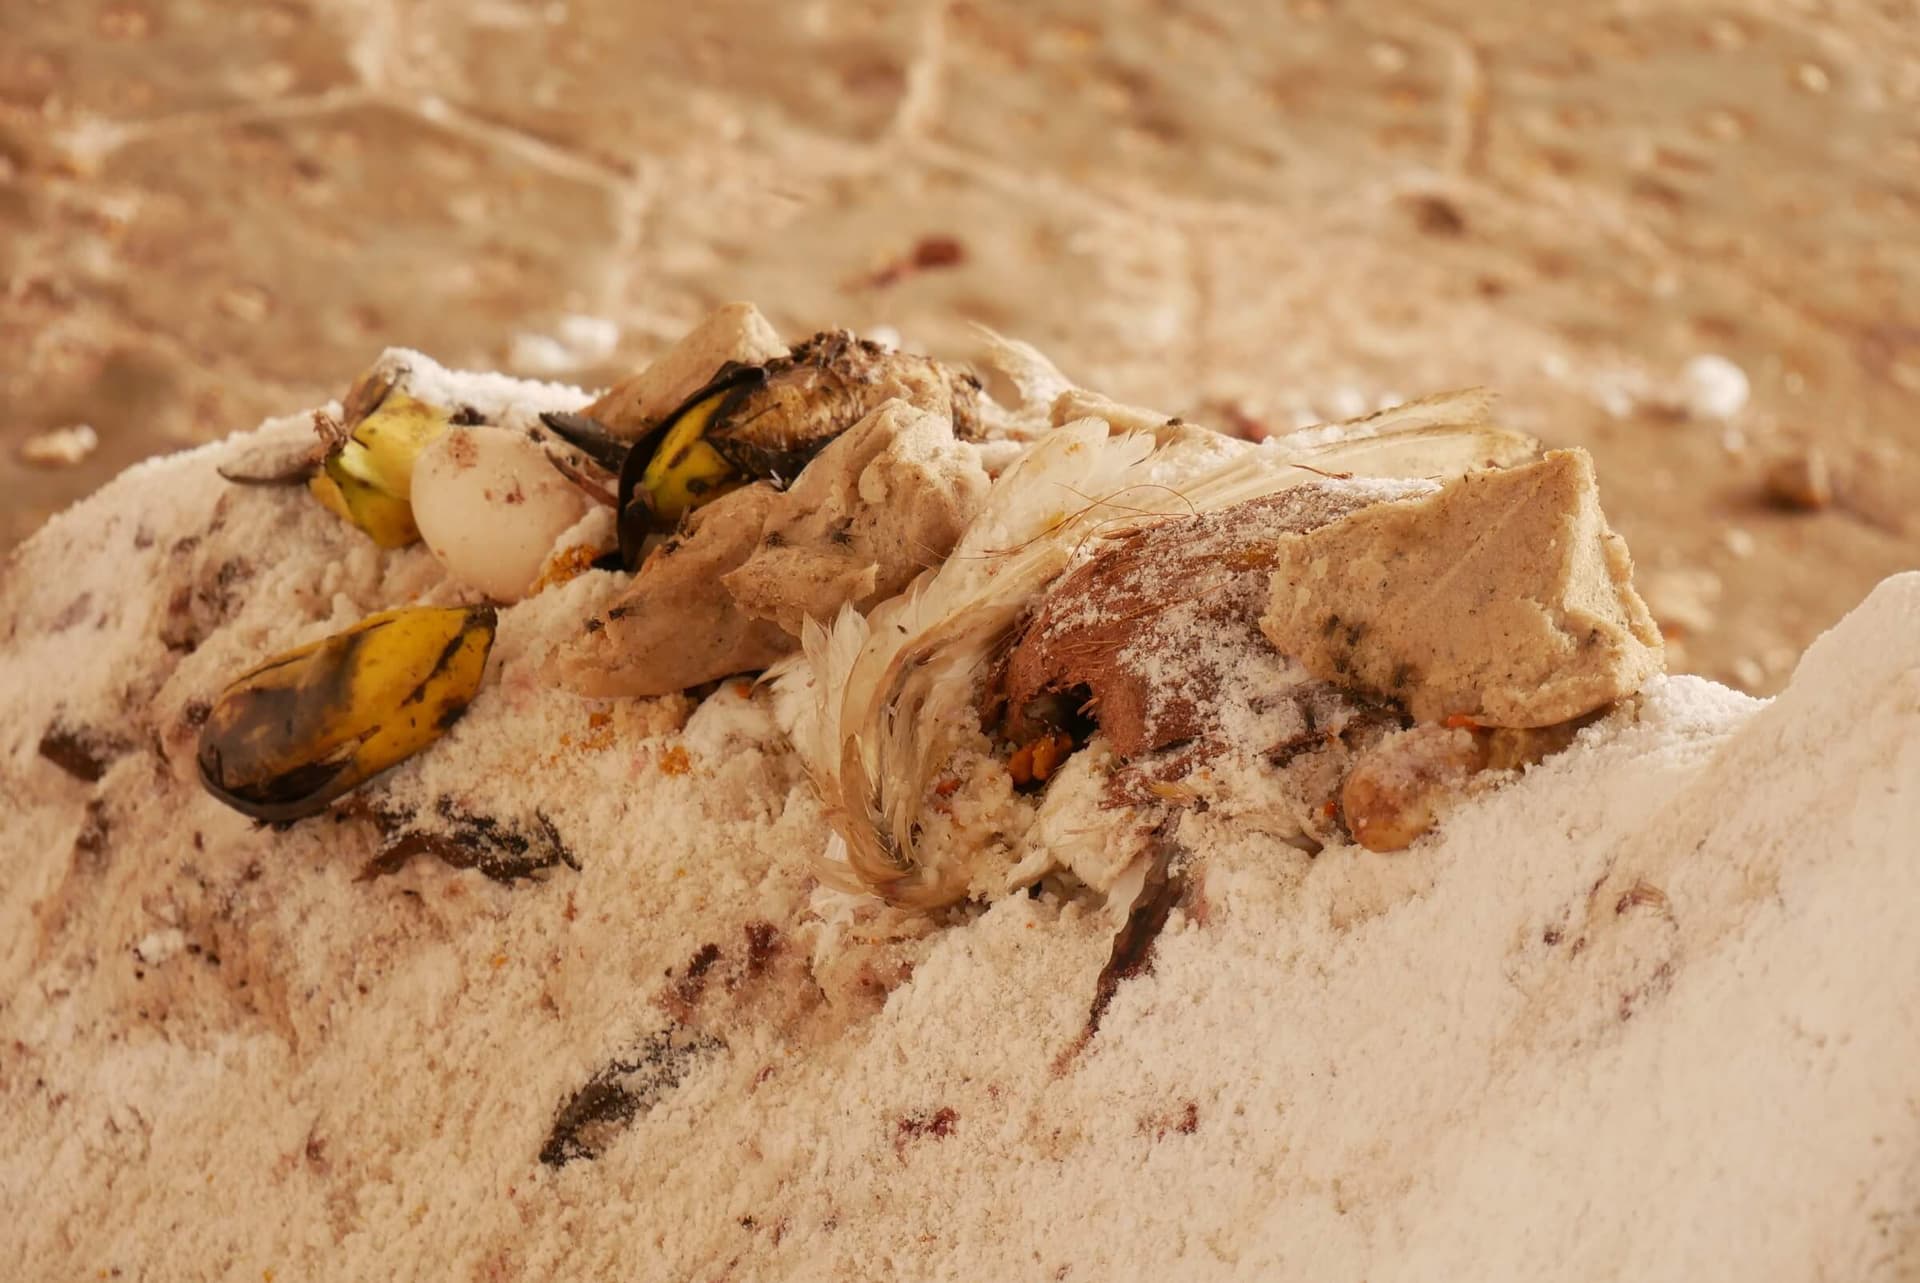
<box><xmin>200</xmin><ymin>607</ymin><xmax>493</xmax><ymax>820</ymax></box>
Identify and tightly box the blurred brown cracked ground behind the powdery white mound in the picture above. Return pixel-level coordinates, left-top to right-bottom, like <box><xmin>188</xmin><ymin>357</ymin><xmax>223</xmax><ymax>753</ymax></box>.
<box><xmin>0</xmin><ymin>0</ymin><xmax>1920</xmax><ymax>691</ymax></box>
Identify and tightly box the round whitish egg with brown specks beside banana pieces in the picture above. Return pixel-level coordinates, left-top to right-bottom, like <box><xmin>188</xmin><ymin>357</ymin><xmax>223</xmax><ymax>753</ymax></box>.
<box><xmin>411</xmin><ymin>426</ymin><xmax>588</xmax><ymax>601</ymax></box>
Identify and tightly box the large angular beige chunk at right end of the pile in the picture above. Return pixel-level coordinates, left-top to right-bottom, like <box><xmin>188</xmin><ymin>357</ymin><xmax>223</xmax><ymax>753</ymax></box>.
<box><xmin>1260</xmin><ymin>449</ymin><xmax>1665</xmax><ymax>726</ymax></box>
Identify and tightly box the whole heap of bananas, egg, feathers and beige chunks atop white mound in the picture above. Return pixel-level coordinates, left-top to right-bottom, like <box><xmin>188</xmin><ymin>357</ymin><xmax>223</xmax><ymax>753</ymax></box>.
<box><xmin>183</xmin><ymin>305</ymin><xmax>1659</xmax><ymax>891</ymax></box>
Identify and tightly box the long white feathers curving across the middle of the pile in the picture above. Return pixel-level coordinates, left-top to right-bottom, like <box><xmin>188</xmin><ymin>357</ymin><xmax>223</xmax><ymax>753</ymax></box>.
<box><xmin>770</xmin><ymin>392</ymin><xmax>1536</xmax><ymax>908</ymax></box>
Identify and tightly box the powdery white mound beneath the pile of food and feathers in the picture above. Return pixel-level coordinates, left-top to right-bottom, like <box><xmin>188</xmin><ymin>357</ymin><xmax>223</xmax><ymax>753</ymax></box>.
<box><xmin>0</xmin><ymin>363</ymin><xmax>1920</xmax><ymax>1283</ymax></box>
